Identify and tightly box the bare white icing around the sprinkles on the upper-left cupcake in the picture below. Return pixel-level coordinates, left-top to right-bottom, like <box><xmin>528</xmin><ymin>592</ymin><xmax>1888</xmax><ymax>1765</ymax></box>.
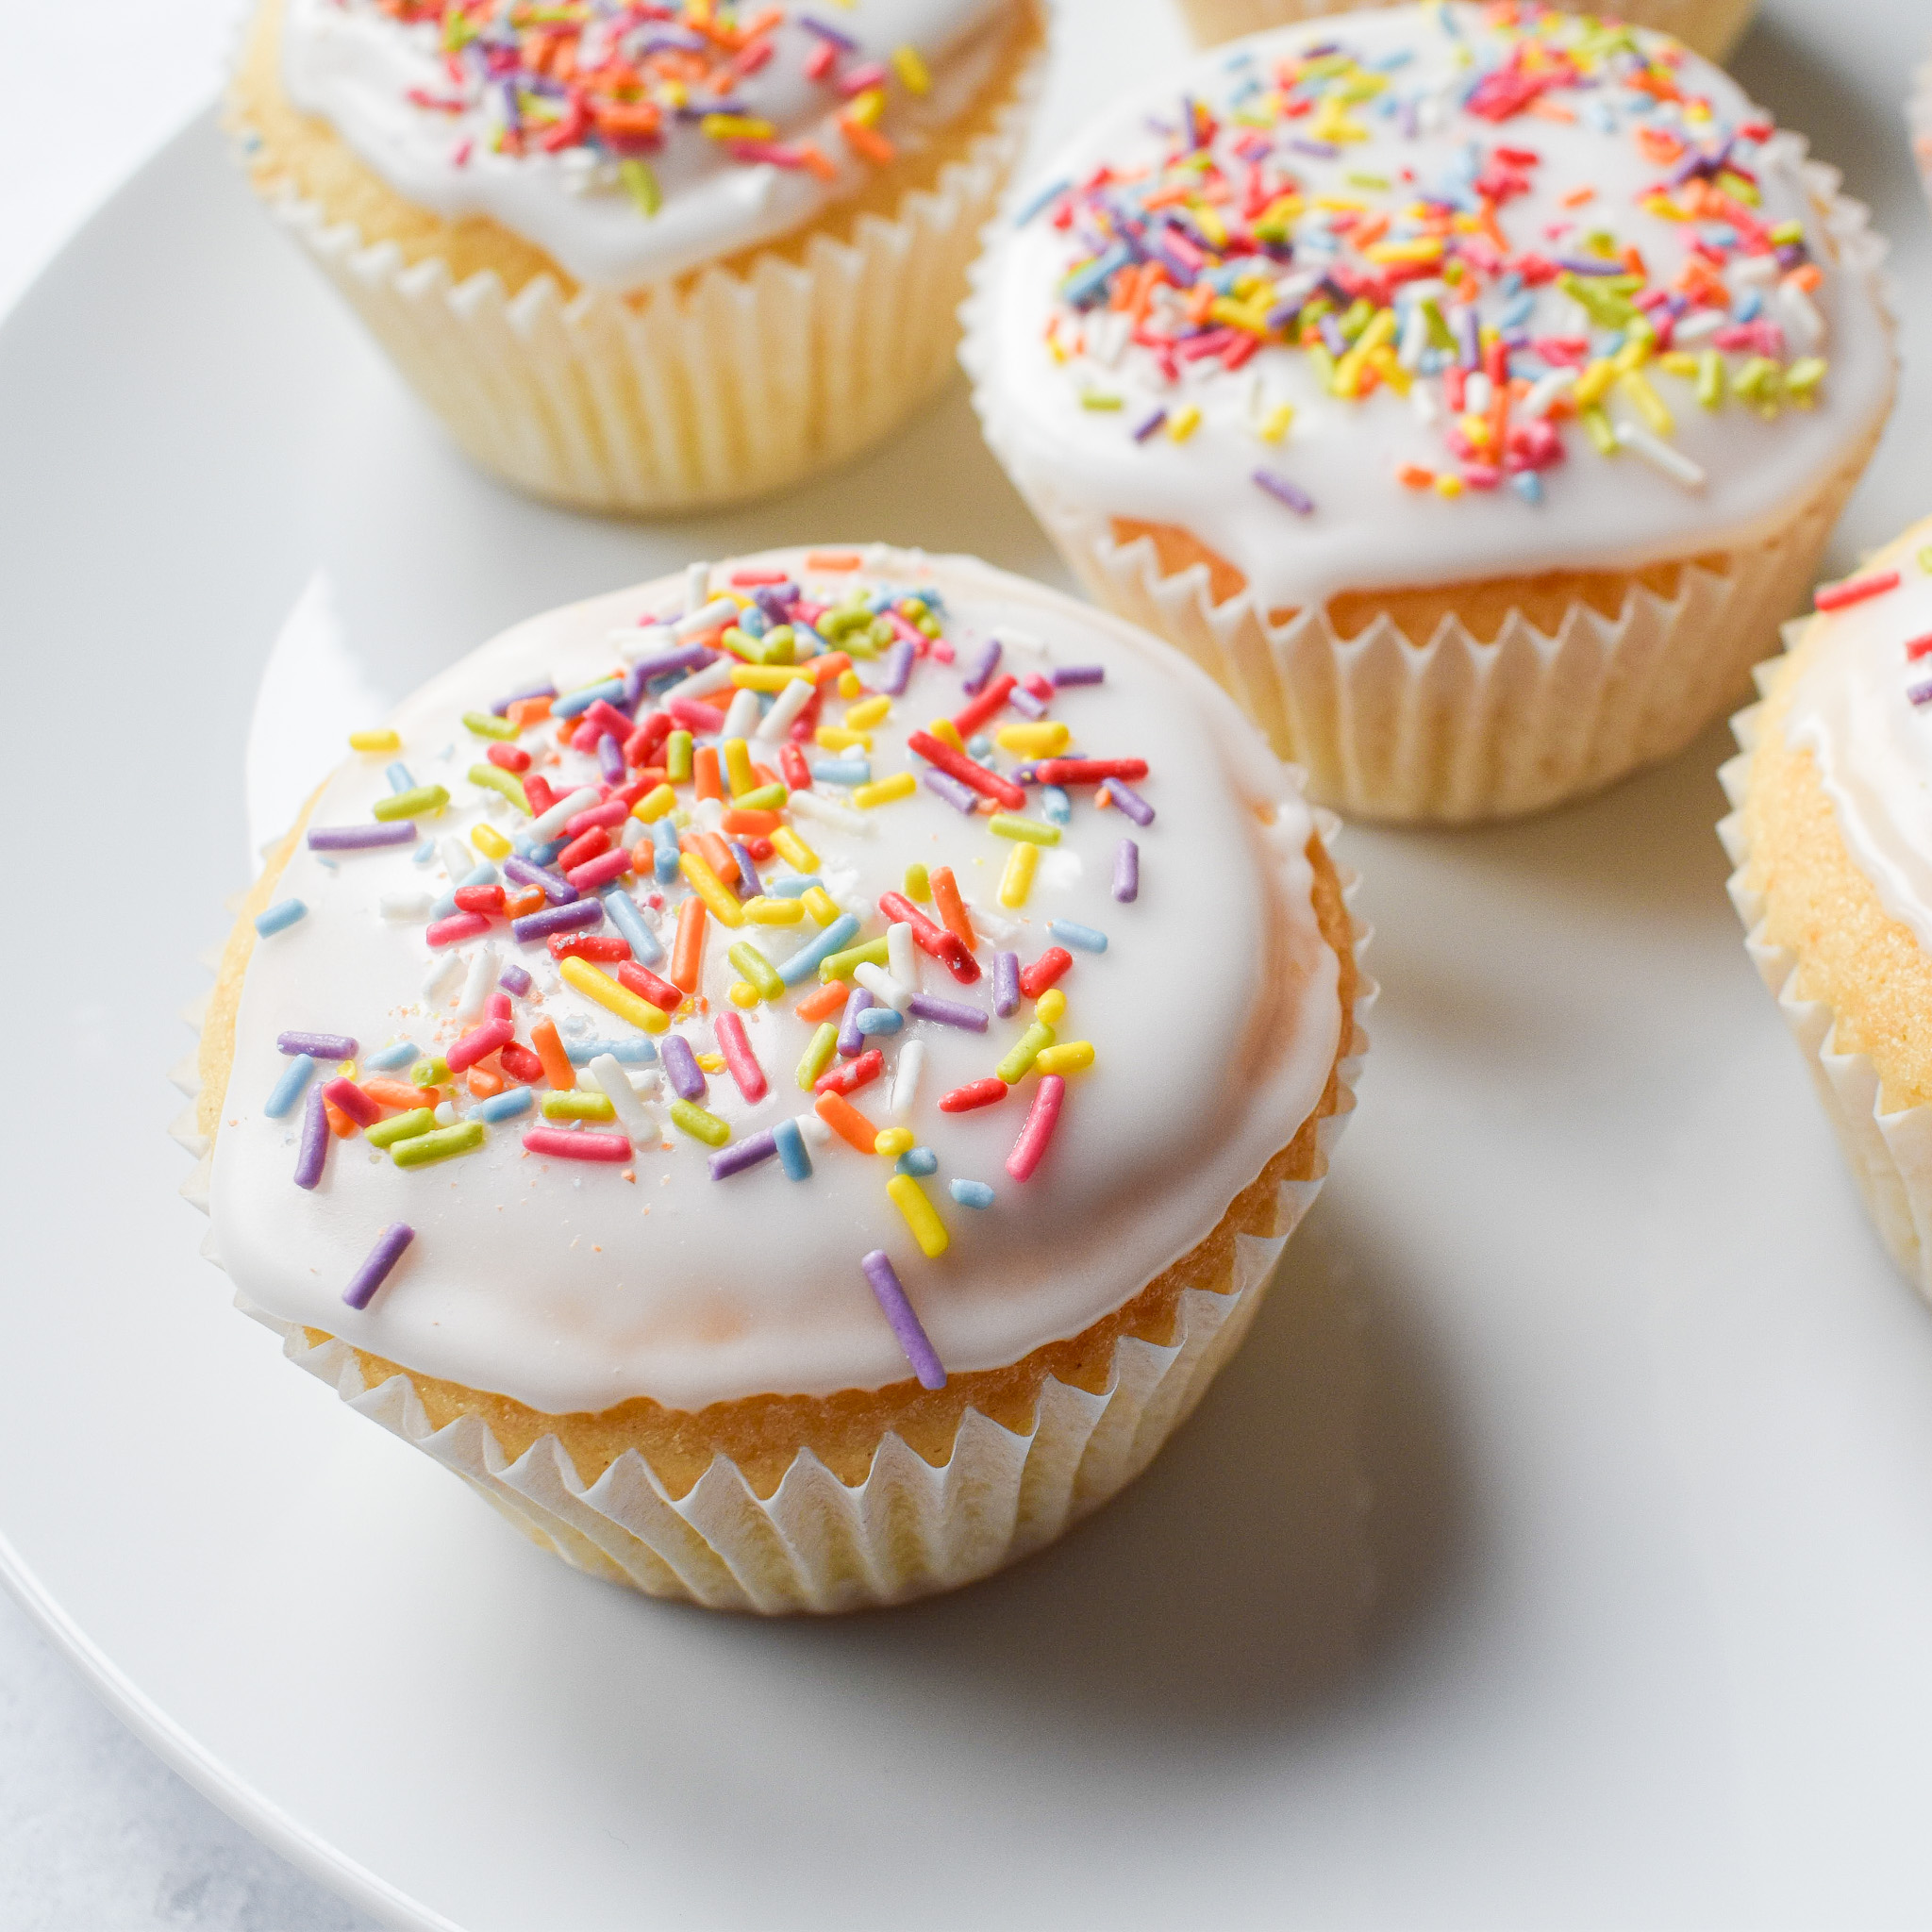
<box><xmin>282</xmin><ymin>0</ymin><xmax>1018</xmax><ymax>290</ymax></box>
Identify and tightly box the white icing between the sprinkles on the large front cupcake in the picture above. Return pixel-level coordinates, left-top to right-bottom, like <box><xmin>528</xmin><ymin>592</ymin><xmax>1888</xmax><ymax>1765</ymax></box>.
<box><xmin>212</xmin><ymin>551</ymin><xmax>1341</xmax><ymax>1412</ymax></box>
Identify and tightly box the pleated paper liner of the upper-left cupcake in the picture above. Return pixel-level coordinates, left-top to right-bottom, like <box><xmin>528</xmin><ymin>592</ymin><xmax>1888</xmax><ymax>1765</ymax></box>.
<box><xmin>235</xmin><ymin>32</ymin><xmax>1045</xmax><ymax>514</ymax></box>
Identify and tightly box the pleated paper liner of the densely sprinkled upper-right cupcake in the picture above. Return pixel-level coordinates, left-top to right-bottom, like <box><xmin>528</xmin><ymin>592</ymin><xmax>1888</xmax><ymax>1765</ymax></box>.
<box><xmin>960</xmin><ymin>148</ymin><xmax>1886</xmax><ymax>823</ymax></box>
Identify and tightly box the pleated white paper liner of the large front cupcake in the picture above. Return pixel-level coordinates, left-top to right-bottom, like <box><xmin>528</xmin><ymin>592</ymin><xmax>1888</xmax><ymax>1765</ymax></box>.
<box><xmin>170</xmin><ymin>846</ymin><xmax>1377</xmax><ymax>1615</ymax></box>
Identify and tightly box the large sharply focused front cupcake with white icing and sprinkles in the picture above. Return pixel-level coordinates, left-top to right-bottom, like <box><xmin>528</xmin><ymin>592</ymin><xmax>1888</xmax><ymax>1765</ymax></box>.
<box><xmin>174</xmin><ymin>551</ymin><xmax>1370</xmax><ymax>1611</ymax></box>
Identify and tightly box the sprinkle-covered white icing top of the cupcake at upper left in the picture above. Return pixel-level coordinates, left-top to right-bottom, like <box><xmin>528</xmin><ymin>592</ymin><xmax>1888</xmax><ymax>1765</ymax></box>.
<box><xmin>280</xmin><ymin>0</ymin><xmax>1016</xmax><ymax>288</ymax></box>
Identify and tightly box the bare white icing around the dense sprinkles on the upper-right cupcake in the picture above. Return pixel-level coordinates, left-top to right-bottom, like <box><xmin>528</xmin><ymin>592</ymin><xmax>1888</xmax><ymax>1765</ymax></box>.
<box><xmin>974</xmin><ymin>6</ymin><xmax>1893</xmax><ymax>608</ymax></box>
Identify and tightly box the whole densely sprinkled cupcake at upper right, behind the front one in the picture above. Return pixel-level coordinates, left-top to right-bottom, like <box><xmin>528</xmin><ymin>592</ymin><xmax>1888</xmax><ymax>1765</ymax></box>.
<box><xmin>962</xmin><ymin>4</ymin><xmax>1895</xmax><ymax>821</ymax></box>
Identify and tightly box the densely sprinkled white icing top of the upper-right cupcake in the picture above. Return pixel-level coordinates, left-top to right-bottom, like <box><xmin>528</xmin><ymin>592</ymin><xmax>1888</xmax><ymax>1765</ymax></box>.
<box><xmin>970</xmin><ymin>4</ymin><xmax>1893</xmax><ymax>608</ymax></box>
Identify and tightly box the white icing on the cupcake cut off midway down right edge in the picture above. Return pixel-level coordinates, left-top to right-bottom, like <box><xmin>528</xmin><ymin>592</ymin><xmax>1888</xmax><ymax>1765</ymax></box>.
<box><xmin>1785</xmin><ymin>524</ymin><xmax>1932</xmax><ymax>953</ymax></box>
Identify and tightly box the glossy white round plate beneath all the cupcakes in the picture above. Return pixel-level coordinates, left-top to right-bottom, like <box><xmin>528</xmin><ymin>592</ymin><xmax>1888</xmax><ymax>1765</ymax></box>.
<box><xmin>11</xmin><ymin>0</ymin><xmax>1932</xmax><ymax>1932</ymax></box>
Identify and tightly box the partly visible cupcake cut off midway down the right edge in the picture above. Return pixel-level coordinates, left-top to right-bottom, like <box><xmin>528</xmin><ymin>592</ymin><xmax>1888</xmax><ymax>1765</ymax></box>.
<box><xmin>1720</xmin><ymin>518</ymin><xmax>1932</xmax><ymax>1298</ymax></box>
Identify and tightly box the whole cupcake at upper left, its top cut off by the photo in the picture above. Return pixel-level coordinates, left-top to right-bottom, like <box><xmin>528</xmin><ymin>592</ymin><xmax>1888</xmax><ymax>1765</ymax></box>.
<box><xmin>230</xmin><ymin>0</ymin><xmax>1043</xmax><ymax>514</ymax></box>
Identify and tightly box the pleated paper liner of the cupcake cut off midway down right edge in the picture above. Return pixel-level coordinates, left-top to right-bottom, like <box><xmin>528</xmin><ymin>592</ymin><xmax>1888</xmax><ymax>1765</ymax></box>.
<box><xmin>1718</xmin><ymin>645</ymin><xmax>1932</xmax><ymax>1302</ymax></box>
